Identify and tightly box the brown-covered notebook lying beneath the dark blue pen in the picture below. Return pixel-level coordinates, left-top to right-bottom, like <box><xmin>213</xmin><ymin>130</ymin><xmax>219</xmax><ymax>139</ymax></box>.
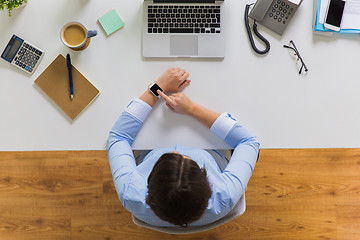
<box><xmin>34</xmin><ymin>54</ymin><xmax>100</xmax><ymax>120</ymax></box>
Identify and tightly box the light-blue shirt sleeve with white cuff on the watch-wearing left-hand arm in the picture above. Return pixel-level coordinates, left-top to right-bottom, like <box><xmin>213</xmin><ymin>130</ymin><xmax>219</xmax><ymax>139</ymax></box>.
<box><xmin>108</xmin><ymin>99</ymin><xmax>152</xmax><ymax>202</ymax></box>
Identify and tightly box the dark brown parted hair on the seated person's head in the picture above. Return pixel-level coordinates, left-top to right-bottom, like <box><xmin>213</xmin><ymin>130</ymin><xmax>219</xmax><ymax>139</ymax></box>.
<box><xmin>146</xmin><ymin>153</ymin><xmax>212</xmax><ymax>227</ymax></box>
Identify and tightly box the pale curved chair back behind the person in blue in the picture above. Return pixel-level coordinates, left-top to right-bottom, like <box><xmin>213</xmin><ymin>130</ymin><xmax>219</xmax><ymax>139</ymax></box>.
<box><xmin>132</xmin><ymin>193</ymin><xmax>246</xmax><ymax>234</ymax></box>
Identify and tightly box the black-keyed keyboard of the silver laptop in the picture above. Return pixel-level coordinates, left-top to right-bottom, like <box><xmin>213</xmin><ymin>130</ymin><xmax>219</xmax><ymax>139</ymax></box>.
<box><xmin>148</xmin><ymin>4</ymin><xmax>221</xmax><ymax>34</ymax></box>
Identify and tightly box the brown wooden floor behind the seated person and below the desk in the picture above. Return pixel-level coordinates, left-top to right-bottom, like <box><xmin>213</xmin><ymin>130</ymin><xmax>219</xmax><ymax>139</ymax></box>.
<box><xmin>0</xmin><ymin>149</ymin><xmax>360</xmax><ymax>240</ymax></box>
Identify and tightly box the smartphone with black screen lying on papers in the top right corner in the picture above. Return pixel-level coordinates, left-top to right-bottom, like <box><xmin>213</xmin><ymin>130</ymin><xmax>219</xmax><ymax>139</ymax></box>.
<box><xmin>324</xmin><ymin>0</ymin><xmax>345</xmax><ymax>32</ymax></box>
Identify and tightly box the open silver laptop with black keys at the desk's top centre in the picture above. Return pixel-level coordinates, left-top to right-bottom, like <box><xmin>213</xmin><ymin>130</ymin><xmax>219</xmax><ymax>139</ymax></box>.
<box><xmin>142</xmin><ymin>0</ymin><xmax>225</xmax><ymax>58</ymax></box>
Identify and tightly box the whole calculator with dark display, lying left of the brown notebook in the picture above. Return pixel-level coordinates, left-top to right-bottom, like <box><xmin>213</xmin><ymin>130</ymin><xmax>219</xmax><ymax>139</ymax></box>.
<box><xmin>1</xmin><ymin>34</ymin><xmax>44</xmax><ymax>74</ymax></box>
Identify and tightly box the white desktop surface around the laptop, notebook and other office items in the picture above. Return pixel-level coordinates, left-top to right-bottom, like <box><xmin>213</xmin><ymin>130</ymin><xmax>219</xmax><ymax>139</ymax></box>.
<box><xmin>0</xmin><ymin>0</ymin><xmax>360</xmax><ymax>150</ymax></box>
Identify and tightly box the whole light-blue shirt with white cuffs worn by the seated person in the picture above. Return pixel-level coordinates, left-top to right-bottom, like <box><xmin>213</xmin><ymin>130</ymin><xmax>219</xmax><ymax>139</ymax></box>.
<box><xmin>108</xmin><ymin>99</ymin><xmax>259</xmax><ymax>226</ymax></box>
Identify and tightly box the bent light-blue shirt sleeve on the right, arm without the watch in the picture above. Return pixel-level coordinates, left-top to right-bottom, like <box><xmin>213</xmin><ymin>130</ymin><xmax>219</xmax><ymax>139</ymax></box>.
<box><xmin>210</xmin><ymin>113</ymin><xmax>260</xmax><ymax>204</ymax></box>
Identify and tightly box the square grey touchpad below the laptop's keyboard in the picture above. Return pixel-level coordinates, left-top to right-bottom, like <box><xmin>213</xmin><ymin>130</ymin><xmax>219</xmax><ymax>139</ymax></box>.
<box><xmin>170</xmin><ymin>36</ymin><xmax>198</xmax><ymax>56</ymax></box>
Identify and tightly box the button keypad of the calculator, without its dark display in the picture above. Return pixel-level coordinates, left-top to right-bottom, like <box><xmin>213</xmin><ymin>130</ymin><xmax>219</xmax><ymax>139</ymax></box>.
<box><xmin>12</xmin><ymin>42</ymin><xmax>43</xmax><ymax>74</ymax></box>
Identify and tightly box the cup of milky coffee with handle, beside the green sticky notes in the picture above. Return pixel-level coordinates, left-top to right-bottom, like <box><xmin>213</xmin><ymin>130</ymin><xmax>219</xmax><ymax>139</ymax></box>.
<box><xmin>60</xmin><ymin>22</ymin><xmax>97</xmax><ymax>50</ymax></box>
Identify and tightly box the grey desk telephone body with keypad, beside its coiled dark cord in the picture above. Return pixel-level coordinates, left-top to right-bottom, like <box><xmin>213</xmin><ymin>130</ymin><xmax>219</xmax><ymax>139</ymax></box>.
<box><xmin>249</xmin><ymin>0</ymin><xmax>302</xmax><ymax>35</ymax></box>
